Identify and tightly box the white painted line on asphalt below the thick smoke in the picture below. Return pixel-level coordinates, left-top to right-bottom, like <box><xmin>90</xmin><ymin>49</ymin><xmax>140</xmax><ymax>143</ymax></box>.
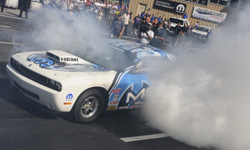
<box><xmin>120</xmin><ymin>133</ymin><xmax>168</xmax><ymax>143</ymax></box>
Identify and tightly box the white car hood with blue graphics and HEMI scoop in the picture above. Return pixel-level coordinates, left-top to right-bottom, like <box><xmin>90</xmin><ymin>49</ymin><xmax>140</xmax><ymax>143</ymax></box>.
<box><xmin>21</xmin><ymin>50</ymin><xmax>110</xmax><ymax>72</ymax></box>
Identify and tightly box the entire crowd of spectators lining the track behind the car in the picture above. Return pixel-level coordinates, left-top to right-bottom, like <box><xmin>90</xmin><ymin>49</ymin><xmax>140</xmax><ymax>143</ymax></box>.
<box><xmin>0</xmin><ymin>0</ymin><xmax>207</xmax><ymax>48</ymax></box>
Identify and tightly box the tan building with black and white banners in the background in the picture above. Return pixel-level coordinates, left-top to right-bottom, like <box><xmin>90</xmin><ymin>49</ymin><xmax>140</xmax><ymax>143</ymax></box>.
<box><xmin>129</xmin><ymin>0</ymin><xmax>250</xmax><ymax>28</ymax></box>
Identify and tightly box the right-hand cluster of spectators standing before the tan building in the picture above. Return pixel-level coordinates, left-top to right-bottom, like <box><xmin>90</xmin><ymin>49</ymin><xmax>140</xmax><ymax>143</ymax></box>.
<box><xmin>121</xmin><ymin>12</ymin><xmax>193</xmax><ymax>48</ymax></box>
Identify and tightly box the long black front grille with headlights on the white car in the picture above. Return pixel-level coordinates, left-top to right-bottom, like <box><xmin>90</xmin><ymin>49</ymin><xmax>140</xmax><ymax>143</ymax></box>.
<box><xmin>10</xmin><ymin>57</ymin><xmax>61</xmax><ymax>91</ymax></box>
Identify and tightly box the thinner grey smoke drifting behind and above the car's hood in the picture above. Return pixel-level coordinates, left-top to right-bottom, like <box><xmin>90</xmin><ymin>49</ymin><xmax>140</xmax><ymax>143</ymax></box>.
<box><xmin>12</xmin><ymin>8</ymin><xmax>107</xmax><ymax>53</ymax></box>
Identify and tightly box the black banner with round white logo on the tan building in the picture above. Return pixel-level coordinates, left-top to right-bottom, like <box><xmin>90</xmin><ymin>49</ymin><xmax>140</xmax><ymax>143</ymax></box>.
<box><xmin>153</xmin><ymin>0</ymin><xmax>186</xmax><ymax>14</ymax></box>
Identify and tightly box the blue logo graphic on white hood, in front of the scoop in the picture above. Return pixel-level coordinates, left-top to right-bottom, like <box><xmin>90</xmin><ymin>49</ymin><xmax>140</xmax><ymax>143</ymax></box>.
<box><xmin>27</xmin><ymin>55</ymin><xmax>54</xmax><ymax>68</ymax></box>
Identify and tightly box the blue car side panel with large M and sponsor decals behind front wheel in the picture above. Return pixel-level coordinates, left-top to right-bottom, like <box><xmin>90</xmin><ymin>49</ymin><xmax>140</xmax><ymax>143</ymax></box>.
<box><xmin>108</xmin><ymin>60</ymin><xmax>149</xmax><ymax>110</ymax></box>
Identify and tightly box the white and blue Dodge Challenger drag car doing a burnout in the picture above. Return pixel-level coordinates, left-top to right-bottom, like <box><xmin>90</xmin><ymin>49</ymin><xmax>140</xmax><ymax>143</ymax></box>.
<box><xmin>6</xmin><ymin>39</ymin><xmax>175</xmax><ymax>123</ymax></box>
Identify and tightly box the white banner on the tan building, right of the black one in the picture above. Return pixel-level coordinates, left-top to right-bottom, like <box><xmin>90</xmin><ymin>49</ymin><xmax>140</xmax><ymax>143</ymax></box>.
<box><xmin>192</xmin><ymin>7</ymin><xmax>227</xmax><ymax>23</ymax></box>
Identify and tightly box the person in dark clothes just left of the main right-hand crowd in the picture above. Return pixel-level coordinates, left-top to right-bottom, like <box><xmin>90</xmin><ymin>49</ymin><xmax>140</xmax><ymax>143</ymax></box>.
<box><xmin>110</xmin><ymin>13</ymin><xmax>125</xmax><ymax>38</ymax></box>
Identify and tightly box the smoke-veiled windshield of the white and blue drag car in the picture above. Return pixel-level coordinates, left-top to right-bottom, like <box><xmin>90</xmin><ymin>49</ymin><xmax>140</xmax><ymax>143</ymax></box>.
<box><xmin>71</xmin><ymin>47</ymin><xmax>136</xmax><ymax>71</ymax></box>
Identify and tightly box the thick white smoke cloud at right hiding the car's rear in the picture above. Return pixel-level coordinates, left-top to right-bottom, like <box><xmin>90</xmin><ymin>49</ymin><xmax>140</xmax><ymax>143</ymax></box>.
<box><xmin>143</xmin><ymin>6</ymin><xmax>250</xmax><ymax>150</ymax></box>
